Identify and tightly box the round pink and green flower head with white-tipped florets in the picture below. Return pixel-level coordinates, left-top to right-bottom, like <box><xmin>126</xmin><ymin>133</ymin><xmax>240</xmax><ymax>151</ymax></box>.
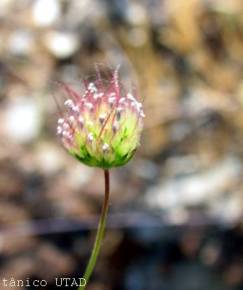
<box><xmin>57</xmin><ymin>70</ymin><xmax>145</xmax><ymax>168</ymax></box>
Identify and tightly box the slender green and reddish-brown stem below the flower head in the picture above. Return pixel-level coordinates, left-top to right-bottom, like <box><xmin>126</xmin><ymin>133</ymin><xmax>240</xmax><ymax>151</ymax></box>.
<box><xmin>79</xmin><ymin>169</ymin><xmax>110</xmax><ymax>290</ymax></box>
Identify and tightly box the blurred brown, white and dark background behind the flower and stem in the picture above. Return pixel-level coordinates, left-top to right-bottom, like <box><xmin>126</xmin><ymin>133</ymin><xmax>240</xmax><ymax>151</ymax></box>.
<box><xmin>0</xmin><ymin>0</ymin><xmax>243</xmax><ymax>290</ymax></box>
